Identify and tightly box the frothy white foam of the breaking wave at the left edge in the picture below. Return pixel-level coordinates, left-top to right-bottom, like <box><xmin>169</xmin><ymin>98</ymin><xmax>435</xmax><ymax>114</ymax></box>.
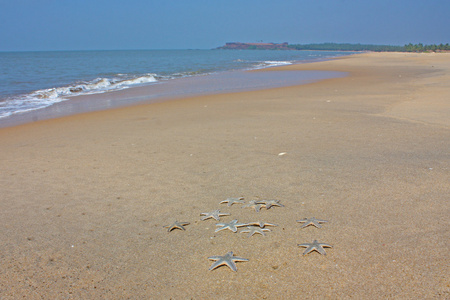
<box><xmin>0</xmin><ymin>74</ymin><xmax>158</xmax><ymax>118</ymax></box>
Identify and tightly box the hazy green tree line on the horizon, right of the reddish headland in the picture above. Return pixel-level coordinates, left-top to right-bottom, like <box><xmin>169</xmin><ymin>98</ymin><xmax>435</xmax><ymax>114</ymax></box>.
<box><xmin>288</xmin><ymin>43</ymin><xmax>450</xmax><ymax>52</ymax></box>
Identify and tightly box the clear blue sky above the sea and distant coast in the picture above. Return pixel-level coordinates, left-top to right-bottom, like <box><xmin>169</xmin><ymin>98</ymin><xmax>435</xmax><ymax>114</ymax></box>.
<box><xmin>0</xmin><ymin>0</ymin><xmax>450</xmax><ymax>51</ymax></box>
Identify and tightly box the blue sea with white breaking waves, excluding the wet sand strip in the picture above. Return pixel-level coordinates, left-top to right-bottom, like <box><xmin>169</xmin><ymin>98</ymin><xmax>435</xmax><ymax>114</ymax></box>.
<box><xmin>0</xmin><ymin>50</ymin><xmax>352</xmax><ymax>120</ymax></box>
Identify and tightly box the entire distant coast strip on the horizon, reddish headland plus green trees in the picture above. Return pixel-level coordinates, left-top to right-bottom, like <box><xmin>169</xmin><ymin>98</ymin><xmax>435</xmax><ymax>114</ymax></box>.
<box><xmin>215</xmin><ymin>42</ymin><xmax>450</xmax><ymax>52</ymax></box>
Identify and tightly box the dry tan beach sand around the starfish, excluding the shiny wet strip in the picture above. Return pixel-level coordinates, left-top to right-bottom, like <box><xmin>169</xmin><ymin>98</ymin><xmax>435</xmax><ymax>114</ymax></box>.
<box><xmin>0</xmin><ymin>53</ymin><xmax>450</xmax><ymax>299</ymax></box>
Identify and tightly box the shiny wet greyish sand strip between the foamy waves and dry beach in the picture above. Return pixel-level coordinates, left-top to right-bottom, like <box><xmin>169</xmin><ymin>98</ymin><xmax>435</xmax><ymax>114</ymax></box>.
<box><xmin>0</xmin><ymin>70</ymin><xmax>346</xmax><ymax>128</ymax></box>
